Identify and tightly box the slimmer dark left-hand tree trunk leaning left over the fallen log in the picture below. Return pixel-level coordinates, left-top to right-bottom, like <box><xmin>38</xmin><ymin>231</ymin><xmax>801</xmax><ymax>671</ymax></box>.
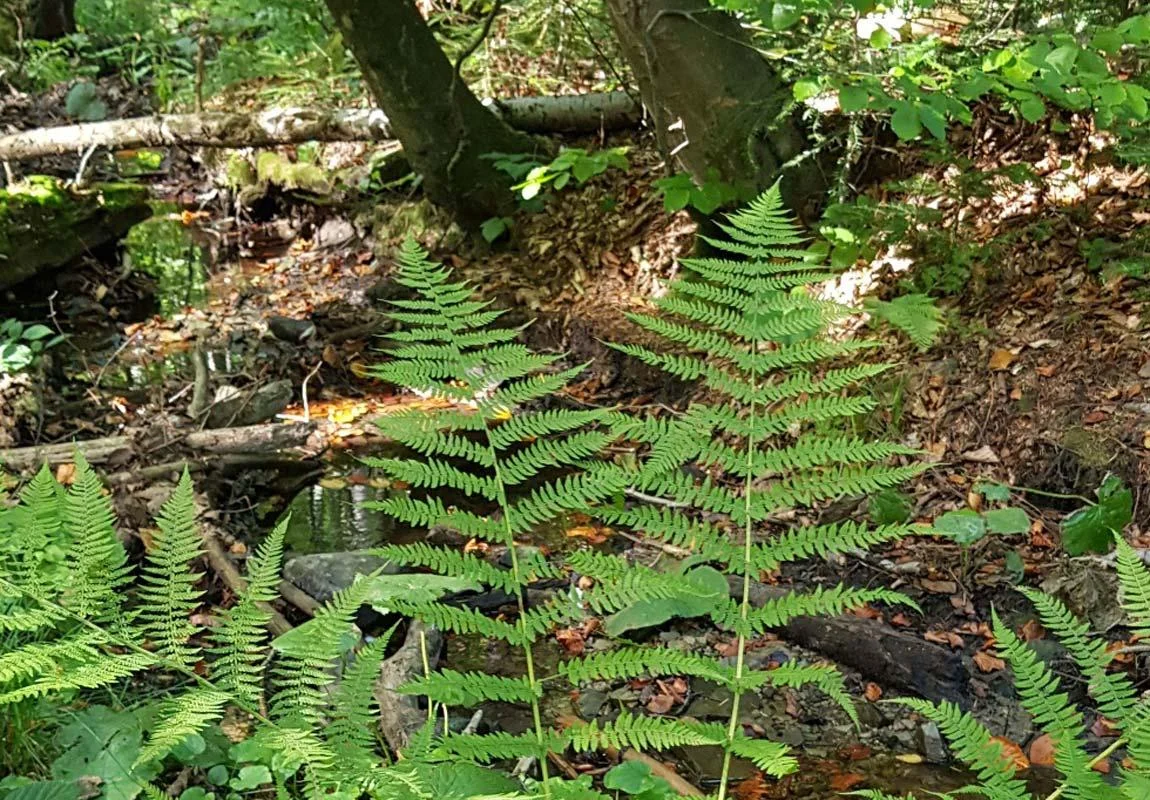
<box><xmin>327</xmin><ymin>0</ymin><xmax>541</xmax><ymax>228</ymax></box>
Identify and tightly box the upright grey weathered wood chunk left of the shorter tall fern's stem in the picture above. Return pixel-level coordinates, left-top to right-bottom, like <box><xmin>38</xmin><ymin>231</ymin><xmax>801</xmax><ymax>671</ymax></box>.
<box><xmin>375</xmin><ymin>621</ymin><xmax>443</xmax><ymax>752</ymax></box>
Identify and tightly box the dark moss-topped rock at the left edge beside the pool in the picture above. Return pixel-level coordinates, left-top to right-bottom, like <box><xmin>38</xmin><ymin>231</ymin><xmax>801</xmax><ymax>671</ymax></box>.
<box><xmin>0</xmin><ymin>176</ymin><xmax>152</xmax><ymax>289</ymax></box>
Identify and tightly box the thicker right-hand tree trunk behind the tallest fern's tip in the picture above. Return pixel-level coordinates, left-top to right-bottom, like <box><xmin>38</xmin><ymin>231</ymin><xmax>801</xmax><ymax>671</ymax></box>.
<box><xmin>607</xmin><ymin>0</ymin><xmax>821</xmax><ymax>213</ymax></box>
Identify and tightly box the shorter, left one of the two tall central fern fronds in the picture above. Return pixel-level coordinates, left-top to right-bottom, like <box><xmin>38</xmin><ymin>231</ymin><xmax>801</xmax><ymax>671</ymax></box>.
<box><xmin>367</xmin><ymin>241</ymin><xmax>749</xmax><ymax>797</ymax></box>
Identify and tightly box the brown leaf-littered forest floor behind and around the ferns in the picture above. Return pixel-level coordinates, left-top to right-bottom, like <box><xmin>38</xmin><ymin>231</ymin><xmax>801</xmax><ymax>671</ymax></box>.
<box><xmin>0</xmin><ymin>70</ymin><xmax>1150</xmax><ymax>798</ymax></box>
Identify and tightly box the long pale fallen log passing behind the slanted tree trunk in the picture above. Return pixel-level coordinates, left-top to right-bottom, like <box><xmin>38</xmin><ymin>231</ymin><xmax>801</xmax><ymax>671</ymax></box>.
<box><xmin>0</xmin><ymin>92</ymin><xmax>642</xmax><ymax>161</ymax></box>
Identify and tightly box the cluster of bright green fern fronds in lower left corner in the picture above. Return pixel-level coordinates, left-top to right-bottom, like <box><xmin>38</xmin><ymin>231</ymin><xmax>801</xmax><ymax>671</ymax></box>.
<box><xmin>0</xmin><ymin>455</ymin><xmax>439</xmax><ymax>800</ymax></box>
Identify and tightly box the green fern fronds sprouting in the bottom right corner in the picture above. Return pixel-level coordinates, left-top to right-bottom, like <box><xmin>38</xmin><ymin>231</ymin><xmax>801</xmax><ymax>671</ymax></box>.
<box><xmin>860</xmin><ymin>537</ymin><xmax>1150</xmax><ymax>800</ymax></box>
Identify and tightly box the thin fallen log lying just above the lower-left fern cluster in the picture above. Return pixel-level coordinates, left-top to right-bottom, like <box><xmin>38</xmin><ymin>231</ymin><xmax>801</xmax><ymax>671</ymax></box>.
<box><xmin>0</xmin><ymin>422</ymin><xmax>315</xmax><ymax>471</ymax></box>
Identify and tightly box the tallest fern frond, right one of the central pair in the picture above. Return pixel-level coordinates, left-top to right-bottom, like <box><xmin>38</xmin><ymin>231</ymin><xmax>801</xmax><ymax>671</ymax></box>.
<box><xmin>568</xmin><ymin>186</ymin><xmax>923</xmax><ymax>800</ymax></box>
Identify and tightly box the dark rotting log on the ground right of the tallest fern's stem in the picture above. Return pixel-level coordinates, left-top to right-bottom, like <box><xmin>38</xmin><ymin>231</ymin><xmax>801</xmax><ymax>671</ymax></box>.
<box><xmin>729</xmin><ymin>577</ymin><xmax>971</xmax><ymax>707</ymax></box>
